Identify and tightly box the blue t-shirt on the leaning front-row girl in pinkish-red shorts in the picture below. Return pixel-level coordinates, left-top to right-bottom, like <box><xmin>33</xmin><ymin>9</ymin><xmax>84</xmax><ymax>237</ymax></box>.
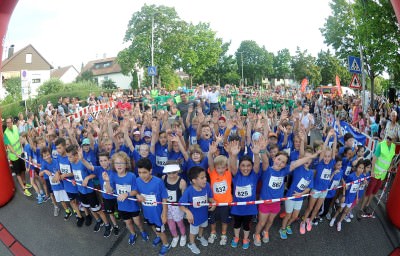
<box><xmin>260</xmin><ymin>166</ymin><xmax>290</xmax><ymax>200</ymax></box>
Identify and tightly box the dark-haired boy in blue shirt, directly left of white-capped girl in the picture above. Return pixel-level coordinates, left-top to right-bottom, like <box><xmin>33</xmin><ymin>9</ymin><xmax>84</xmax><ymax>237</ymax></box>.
<box><xmin>136</xmin><ymin>158</ymin><xmax>170</xmax><ymax>255</ymax></box>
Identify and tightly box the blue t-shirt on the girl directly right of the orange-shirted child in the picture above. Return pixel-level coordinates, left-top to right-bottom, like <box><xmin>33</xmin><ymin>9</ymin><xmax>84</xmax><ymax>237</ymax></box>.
<box><xmin>231</xmin><ymin>170</ymin><xmax>261</xmax><ymax>216</ymax></box>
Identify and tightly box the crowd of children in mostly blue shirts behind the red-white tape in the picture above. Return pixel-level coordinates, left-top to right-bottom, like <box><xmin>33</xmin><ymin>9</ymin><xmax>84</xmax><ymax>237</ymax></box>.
<box><xmin>12</xmin><ymin>87</ymin><xmax>382</xmax><ymax>255</ymax></box>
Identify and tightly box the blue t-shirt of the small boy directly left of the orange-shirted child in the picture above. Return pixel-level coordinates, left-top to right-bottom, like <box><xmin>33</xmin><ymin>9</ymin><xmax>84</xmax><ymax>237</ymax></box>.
<box><xmin>179</xmin><ymin>183</ymin><xmax>213</xmax><ymax>226</ymax></box>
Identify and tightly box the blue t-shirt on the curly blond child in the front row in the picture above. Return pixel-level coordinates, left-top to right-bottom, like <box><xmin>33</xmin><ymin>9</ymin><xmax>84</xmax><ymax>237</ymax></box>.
<box><xmin>110</xmin><ymin>172</ymin><xmax>139</xmax><ymax>212</ymax></box>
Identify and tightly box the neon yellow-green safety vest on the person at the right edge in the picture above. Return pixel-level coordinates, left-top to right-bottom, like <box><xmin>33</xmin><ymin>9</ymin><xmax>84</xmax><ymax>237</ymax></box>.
<box><xmin>374</xmin><ymin>140</ymin><xmax>396</xmax><ymax>180</ymax></box>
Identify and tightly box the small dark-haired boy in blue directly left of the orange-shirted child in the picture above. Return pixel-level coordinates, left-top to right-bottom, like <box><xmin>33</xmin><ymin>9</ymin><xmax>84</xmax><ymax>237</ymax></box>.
<box><xmin>179</xmin><ymin>166</ymin><xmax>215</xmax><ymax>254</ymax></box>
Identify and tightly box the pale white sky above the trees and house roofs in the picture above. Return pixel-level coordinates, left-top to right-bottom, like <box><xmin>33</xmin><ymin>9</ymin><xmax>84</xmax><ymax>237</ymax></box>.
<box><xmin>3</xmin><ymin>0</ymin><xmax>331</xmax><ymax>71</ymax></box>
